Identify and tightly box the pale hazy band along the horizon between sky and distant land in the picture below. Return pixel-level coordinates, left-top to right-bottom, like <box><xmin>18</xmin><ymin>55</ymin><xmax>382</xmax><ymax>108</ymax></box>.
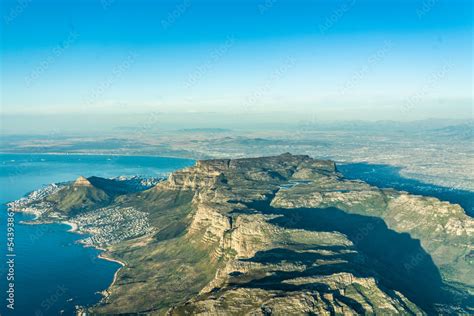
<box><xmin>1</xmin><ymin>112</ymin><xmax>474</xmax><ymax>137</ymax></box>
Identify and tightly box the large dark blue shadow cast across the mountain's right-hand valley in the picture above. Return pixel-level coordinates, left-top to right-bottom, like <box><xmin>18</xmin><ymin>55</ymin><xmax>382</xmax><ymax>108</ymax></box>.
<box><xmin>237</xmin><ymin>199</ymin><xmax>470</xmax><ymax>314</ymax></box>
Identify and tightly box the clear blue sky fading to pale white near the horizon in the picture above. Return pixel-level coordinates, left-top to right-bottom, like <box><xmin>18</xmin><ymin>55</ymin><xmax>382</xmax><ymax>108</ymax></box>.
<box><xmin>0</xmin><ymin>0</ymin><xmax>473</xmax><ymax>130</ymax></box>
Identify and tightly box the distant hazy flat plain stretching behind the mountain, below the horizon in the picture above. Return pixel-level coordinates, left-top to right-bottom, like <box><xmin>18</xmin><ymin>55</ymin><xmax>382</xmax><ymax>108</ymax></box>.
<box><xmin>0</xmin><ymin>121</ymin><xmax>474</xmax><ymax>191</ymax></box>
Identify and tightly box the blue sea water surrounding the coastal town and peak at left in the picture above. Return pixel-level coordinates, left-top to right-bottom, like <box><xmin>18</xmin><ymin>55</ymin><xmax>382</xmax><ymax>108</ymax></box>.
<box><xmin>0</xmin><ymin>154</ymin><xmax>193</xmax><ymax>316</ymax></box>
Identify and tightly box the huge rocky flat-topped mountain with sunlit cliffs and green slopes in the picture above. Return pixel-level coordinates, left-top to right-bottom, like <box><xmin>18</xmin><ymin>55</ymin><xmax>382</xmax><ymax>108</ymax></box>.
<box><xmin>9</xmin><ymin>154</ymin><xmax>474</xmax><ymax>315</ymax></box>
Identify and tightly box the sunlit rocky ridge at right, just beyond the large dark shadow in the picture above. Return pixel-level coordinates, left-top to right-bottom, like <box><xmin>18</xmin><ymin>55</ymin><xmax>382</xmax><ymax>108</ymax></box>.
<box><xmin>272</xmin><ymin>177</ymin><xmax>474</xmax><ymax>294</ymax></box>
